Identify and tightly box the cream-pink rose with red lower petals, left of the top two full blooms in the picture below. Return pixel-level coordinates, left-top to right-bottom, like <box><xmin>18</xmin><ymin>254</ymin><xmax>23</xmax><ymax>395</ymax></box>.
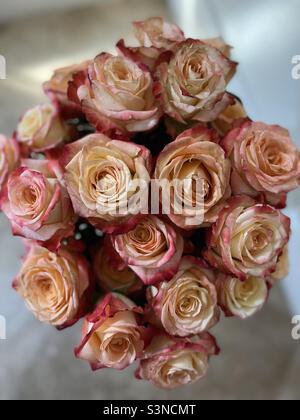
<box><xmin>71</xmin><ymin>53</ymin><xmax>161</xmax><ymax>133</ymax></box>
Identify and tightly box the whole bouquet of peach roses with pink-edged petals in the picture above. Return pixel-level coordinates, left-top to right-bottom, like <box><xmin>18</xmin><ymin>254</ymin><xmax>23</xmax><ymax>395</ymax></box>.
<box><xmin>0</xmin><ymin>18</ymin><xmax>300</xmax><ymax>389</ymax></box>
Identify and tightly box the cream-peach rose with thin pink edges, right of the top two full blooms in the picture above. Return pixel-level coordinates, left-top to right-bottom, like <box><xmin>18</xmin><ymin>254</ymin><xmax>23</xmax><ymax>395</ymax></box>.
<box><xmin>156</xmin><ymin>39</ymin><xmax>236</xmax><ymax>123</ymax></box>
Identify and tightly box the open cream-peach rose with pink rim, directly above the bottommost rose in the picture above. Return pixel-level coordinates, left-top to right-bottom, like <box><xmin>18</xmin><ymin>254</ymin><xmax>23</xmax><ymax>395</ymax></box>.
<box><xmin>148</xmin><ymin>257</ymin><xmax>220</xmax><ymax>337</ymax></box>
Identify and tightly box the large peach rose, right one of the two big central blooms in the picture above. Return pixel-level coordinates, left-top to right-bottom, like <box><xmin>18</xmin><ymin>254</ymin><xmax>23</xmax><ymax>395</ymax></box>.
<box><xmin>155</xmin><ymin>126</ymin><xmax>231</xmax><ymax>230</ymax></box>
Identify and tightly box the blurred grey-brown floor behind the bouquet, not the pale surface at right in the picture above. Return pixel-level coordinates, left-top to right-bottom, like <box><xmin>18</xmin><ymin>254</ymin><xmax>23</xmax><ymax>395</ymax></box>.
<box><xmin>0</xmin><ymin>0</ymin><xmax>300</xmax><ymax>400</ymax></box>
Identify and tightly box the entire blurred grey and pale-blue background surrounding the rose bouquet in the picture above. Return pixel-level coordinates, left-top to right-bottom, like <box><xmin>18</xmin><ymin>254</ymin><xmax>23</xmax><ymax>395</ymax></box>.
<box><xmin>0</xmin><ymin>0</ymin><xmax>300</xmax><ymax>400</ymax></box>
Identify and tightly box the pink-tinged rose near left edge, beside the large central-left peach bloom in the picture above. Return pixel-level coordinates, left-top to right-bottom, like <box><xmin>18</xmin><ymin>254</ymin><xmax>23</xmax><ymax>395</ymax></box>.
<box><xmin>1</xmin><ymin>159</ymin><xmax>76</xmax><ymax>250</ymax></box>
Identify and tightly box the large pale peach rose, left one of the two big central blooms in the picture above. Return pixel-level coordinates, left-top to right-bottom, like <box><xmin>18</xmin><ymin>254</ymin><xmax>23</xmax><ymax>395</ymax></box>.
<box><xmin>61</xmin><ymin>134</ymin><xmax>151</xmax><ymax>233</ymax></box>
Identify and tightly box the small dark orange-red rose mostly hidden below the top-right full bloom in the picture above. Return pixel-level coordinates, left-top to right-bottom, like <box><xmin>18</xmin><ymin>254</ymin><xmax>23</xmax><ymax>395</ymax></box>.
<box><xmin>212</xmin><ymin>99</ymin><xmax>247</xmax><ymax>137</ymax></box>
